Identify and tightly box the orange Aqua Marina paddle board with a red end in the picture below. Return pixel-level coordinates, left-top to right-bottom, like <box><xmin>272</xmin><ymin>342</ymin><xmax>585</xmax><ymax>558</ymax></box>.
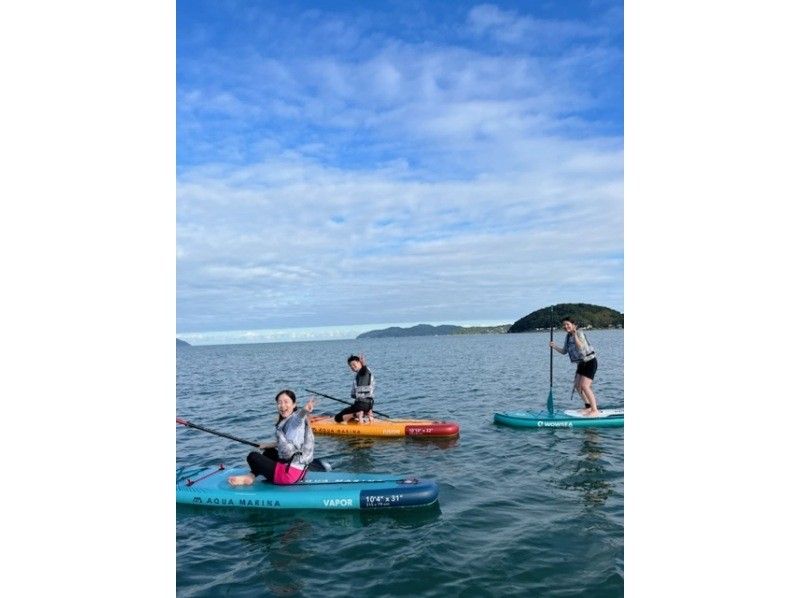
<box><xmin>310</xmin><ymin>415</ymin><xmax>459</xmax><ymax>438</ymax></box>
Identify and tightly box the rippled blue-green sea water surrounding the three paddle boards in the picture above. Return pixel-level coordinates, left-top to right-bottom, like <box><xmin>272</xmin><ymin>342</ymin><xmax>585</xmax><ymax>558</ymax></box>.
<box><xmin>176</xmin><ymin>330</ymin><xmax>624</xmax><ymax>596</ymax></box>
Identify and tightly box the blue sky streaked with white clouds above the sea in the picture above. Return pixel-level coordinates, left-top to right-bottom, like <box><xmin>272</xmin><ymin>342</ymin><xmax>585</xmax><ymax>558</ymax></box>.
<box><xmin>176</xmin><ymin>0</ymin><xmax>624</xmax><ymax>344</ymax></box>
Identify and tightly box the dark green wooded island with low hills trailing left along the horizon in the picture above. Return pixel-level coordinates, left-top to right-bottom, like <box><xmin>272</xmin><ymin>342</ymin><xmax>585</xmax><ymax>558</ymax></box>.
<box><xmin>356</xmin><ymin>303</ymin><xmax>625</xmax><ymax>338</ymax></box>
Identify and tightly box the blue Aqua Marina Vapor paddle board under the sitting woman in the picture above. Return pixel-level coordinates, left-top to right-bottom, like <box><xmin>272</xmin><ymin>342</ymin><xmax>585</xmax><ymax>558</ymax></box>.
<box><xmin>175</xmin><ymin>466</ymin><xmax>439</xmax><ymax>510</ymax></box>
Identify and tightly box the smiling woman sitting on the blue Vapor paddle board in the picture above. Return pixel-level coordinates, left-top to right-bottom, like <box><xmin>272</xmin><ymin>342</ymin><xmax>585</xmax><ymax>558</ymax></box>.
<box><xmin>228</xmin><ymin>390</ymin><xmax>314</xmax><ymax>486</ymax></box>
